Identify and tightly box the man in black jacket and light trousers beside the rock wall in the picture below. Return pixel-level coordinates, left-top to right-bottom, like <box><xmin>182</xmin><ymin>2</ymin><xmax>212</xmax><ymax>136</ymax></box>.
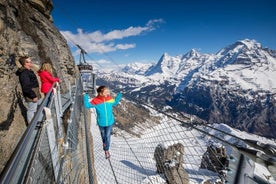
<box><xmin>16</xmin><ymin>56</ymin><xmax>41</xmax><ymax>123</ymax></box>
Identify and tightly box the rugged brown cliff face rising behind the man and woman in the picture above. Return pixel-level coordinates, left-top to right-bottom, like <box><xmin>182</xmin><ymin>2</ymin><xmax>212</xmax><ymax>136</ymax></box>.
<box><xmin>0</xmin><ymin>0</ymin><xmax>77</xmax><ymax>170</ymax></box>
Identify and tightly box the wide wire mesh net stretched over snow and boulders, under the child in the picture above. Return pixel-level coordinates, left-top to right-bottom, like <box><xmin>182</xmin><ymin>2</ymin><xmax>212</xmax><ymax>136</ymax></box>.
<box><xmin>91</xmin><ymin>93</ymin><xmax>276</xmax><ymax>184</ymax></box>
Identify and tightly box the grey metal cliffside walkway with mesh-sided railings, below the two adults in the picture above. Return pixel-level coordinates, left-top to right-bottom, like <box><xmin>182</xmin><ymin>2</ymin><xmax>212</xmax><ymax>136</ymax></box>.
<box><xmin>0</xmin><ymin>78</ymin><xmax>95</xmax><ymax>184</ymax></box>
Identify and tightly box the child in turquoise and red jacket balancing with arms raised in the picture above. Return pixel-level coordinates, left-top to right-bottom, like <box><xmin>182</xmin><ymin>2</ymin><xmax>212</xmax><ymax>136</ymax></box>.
<box><xmin>84</xmin><ymin>86</ymin><xmax>122</xmax><ymax>159</ymax></box>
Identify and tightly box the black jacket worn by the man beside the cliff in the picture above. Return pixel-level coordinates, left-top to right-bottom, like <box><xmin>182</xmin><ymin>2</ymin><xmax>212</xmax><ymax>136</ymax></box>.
<box><xmin>16</xmin><ymin>67</ymin><xmax>39</xmax><ymax>101</ymax></box>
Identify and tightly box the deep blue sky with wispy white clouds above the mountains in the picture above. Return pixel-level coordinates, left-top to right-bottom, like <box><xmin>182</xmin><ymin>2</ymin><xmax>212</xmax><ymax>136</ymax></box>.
<box><xmin>52</xmin><ymin>0</ymin><xmax>276</xmax><ymax>65</ymax></box>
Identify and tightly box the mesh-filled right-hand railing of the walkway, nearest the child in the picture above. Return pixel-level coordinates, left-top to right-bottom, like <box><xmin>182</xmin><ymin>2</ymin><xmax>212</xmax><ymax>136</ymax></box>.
<box><xmin>57</xmin><ymin>75</ymin><xmax>93</xmax><ymax>183</ymax></box>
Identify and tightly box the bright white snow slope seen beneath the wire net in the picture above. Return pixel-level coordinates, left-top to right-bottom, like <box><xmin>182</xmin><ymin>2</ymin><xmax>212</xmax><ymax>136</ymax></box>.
<box><xmin>91</xmin><ymin>104</ymin><xmax>276</xmax><ymax>184</ymax></box>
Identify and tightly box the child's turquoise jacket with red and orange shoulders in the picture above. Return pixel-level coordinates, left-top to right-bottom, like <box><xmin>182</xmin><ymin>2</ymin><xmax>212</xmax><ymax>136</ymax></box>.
<box><xmin>83</xmin><ymin>93</ymin><xmax>122</xmax><ymax>127</ymax></box>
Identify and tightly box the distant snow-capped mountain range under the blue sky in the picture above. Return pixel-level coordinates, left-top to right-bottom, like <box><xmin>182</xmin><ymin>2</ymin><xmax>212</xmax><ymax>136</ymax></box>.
<box><xmin>97</xmin><ymin>39</ymin><xmax>276</xmax><ymax>138</ymax></box>
